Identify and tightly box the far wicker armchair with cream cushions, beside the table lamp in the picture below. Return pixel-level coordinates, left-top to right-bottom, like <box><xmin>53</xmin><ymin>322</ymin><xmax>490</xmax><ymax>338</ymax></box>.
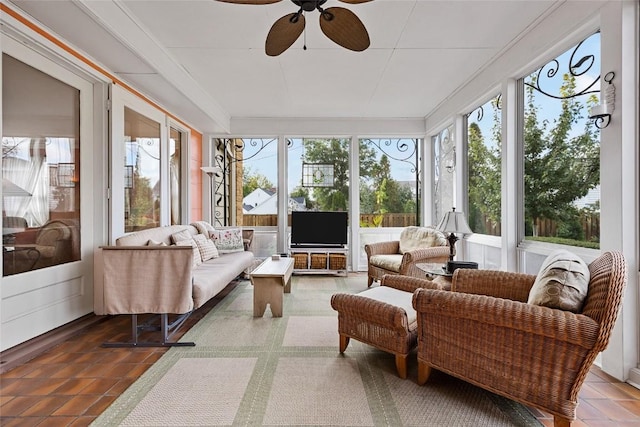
<box><xmin>364</xmin><ymin>227</ymin><xmax>449</xmax><ymax>287</ymax></box>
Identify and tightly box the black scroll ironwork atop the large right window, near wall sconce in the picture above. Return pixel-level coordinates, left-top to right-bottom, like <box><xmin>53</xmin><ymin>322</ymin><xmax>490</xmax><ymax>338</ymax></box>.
<box><xmin>524</xmin><ymin>33</ymin><xmax>600</xmax><ymax>100</ymax></box>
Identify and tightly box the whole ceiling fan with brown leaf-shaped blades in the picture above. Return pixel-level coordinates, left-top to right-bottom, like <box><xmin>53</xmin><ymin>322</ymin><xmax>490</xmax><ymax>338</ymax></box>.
<box><xmin>218</xmin><ymin>0</ymin><xmax>372</xmax><ymax>56</ymax></box>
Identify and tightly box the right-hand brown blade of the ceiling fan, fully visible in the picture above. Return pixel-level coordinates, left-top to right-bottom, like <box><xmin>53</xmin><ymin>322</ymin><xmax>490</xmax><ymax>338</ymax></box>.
<box><xmin>320</xmin><ymin>7</ymin><xmax>370</xmax><ymax>52</ymax></box>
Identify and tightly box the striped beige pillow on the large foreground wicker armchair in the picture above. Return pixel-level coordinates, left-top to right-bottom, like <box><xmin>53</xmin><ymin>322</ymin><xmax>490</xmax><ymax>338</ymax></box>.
<box><xmin>528</xmin><ymin>249</ymin><xmax>590</xmax><ymax>313</ymax></box>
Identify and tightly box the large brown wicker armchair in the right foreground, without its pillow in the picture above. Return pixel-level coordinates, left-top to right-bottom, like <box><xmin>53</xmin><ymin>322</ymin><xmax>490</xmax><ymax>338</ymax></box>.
<box><xmin>413</xmin><ymin>252</ymin><xmax>626</xmax><ymax>426</ymax></box>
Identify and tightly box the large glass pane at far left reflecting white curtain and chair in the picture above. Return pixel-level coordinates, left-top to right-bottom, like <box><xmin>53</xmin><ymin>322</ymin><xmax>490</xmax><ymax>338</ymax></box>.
<box><xmin>2</xmin><ymin>54</ymin><xmax>81</xmax><ymax>276</ymax></box>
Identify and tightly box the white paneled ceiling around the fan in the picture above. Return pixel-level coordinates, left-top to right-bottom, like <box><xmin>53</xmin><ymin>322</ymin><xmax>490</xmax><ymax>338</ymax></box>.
<box><xmin>7</xmin><ymin>0</ymin><xmax>584</xmax><ymax>132</ymax></box>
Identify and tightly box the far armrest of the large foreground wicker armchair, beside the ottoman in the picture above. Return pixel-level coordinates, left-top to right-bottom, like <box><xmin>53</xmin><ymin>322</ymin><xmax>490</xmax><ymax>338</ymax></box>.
<box><xmin>451</xmin><ymin>269</ymin><xmax>536</xmax><ymax>302</ymax></box>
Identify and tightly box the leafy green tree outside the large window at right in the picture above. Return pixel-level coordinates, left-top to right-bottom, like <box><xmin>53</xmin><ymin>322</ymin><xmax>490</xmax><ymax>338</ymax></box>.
<box><xmin>524</xmin><ymin>74</ymin><xmax>600</xmax><ymax>237</ymax></box>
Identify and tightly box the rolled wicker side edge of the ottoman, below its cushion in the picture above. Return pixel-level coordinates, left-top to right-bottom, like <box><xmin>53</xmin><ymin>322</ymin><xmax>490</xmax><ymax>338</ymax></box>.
<box><xmin>331</xmin><ymin>293</ymin><xmax>409</xmax><ymax>333</ymax></box>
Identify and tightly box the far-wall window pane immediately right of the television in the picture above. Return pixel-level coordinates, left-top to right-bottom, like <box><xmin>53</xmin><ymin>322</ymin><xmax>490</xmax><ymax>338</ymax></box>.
<box><xmin>359</xmin><ymin>139</ymin><xmax>420</xmax><ymax>227</ymax></box>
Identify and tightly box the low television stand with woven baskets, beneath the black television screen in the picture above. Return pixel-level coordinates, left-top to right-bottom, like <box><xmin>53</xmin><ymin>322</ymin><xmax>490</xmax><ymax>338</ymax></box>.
<box><xmin>289</xmin><ymin>246</ymin><xmax>349</xmax><ymax>276</ymax></box>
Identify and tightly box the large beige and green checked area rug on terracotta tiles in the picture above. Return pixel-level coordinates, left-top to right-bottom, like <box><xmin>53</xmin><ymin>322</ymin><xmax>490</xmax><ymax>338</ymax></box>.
<box><xmin>92</xmin><ymin>275</ymin><xmax>541</xmax><ymax>427</ymax></box>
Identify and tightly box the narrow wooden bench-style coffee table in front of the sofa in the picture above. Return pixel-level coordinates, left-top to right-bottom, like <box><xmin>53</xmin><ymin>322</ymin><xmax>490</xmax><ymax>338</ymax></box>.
<box><xmin>251</xmin><ymin>257</ymin><xmax>293</xmax><ymax>317</ymax></box>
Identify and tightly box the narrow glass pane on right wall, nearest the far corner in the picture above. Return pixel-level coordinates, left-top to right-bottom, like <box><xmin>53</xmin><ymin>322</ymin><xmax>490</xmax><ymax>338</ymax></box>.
<box><xmin>431</xmin><ymin>125</ymin><xmax>456</xmax><ymax>225</ymax></box>
